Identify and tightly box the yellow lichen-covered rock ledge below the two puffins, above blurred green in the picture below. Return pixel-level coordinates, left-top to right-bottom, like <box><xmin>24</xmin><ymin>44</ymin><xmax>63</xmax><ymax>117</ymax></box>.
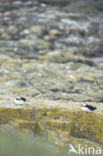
<box><xmin>0</xmin><ymin>98</ymin><xmax>103</xmax><ymax>153</ymax></box>
